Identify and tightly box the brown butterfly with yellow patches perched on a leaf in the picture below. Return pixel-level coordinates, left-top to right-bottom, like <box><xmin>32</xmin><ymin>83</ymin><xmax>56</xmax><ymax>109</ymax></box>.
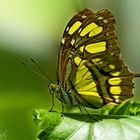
<box><xmin>49</xmin><ymin>9</ymin><xmax>140</xmax><ymax>108</ymax></box>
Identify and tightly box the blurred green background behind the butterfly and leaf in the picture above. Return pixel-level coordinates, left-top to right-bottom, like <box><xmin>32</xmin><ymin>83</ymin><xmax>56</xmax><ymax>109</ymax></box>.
<box><xmin>0</xmin><ymin>0</ymin><xmax>140</xmax><ymax>140</ymax></box>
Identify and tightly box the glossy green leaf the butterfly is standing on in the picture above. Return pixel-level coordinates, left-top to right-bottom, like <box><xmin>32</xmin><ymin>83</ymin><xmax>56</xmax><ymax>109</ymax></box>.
<box><xmin>33</xmin><ymin>102</ymin><xmax>140</xmax><ymax>140</ymax></box>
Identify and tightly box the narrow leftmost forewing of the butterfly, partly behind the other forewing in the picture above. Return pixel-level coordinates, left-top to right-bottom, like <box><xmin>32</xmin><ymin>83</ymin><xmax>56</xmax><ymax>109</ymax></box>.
<box><xmin>57</xmin><ymin>9</ymin><xmax>92</xmax><ymax>86</ymax></box>
